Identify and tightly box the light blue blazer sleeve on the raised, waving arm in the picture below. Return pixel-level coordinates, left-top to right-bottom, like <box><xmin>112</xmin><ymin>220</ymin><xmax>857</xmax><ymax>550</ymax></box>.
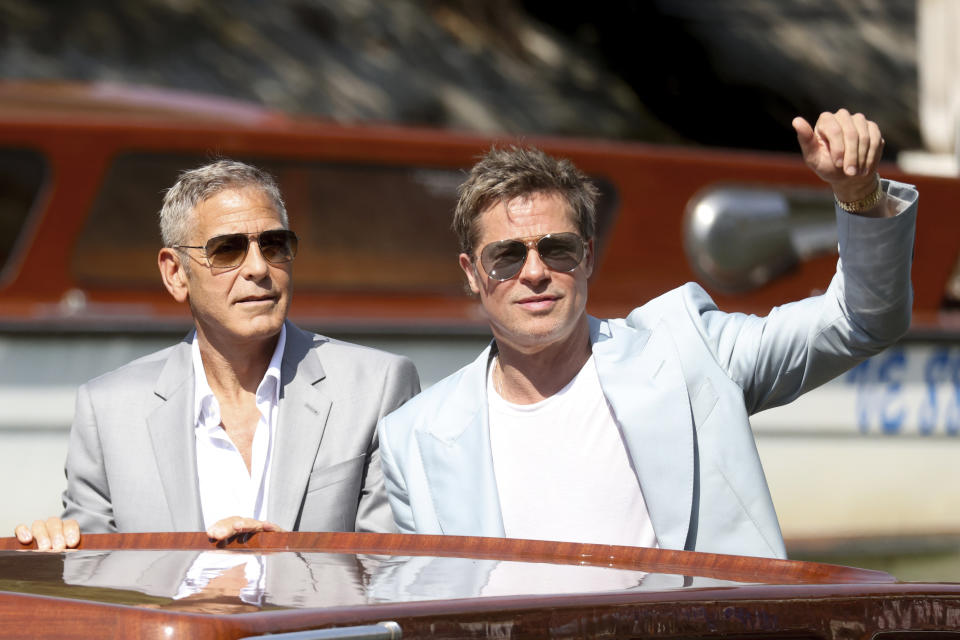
<box><xmin>693</xmin><ymin>181</ymin><xmax>917</xmax><ymax>413</ymax></box>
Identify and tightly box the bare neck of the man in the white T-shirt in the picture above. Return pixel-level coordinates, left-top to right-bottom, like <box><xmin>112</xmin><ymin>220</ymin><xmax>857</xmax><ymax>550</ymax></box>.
<box><xmin>493</xmin><ymin>316</ymin><xmax>591</xmax><ymax>404</ymax></box>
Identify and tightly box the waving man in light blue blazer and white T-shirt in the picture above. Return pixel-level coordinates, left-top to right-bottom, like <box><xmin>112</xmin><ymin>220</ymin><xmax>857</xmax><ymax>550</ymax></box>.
<box><xmin>378</xmin><ymin>109</ymin><xmax>917</xmax><ymax>557</ymax></box>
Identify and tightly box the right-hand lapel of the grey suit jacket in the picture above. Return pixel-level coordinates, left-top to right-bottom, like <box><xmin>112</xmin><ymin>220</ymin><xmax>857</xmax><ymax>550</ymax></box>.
<box><xmin>268</xmin><ymin>322</ymin><xmax>332</xmax><ymax>529</ymax></box>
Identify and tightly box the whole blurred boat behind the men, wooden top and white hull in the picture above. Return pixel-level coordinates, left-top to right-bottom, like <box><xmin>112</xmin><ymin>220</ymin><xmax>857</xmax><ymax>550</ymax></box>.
<box><xmin>0</xmin><ymin>82</ymin><xmax>960</xmax><ymax>553</ymax></box>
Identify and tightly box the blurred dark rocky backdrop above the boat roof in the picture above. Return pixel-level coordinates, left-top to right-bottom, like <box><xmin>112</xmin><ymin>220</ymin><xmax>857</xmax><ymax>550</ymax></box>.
<box><xmin>0</xmin><ymin>0</ymin><xmax>920</xmax><ymax>152</ymax></box>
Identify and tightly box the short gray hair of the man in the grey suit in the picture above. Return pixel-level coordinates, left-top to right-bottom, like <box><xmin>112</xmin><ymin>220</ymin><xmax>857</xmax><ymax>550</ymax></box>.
<box><xmin>160</xmin><ymin>160</ymin><xmax>289</xmax><ymax>247</ymax></box>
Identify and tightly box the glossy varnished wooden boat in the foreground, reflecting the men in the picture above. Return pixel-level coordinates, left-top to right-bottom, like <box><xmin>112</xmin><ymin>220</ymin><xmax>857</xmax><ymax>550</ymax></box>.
<box><xmin>0</xmin><ymin>533</ymin><xmax>960</xmax><ymax>640</ymax></box>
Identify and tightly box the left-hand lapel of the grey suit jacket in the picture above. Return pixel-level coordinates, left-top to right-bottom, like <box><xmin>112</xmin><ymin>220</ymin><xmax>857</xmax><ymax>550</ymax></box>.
<box><xmin>144</xmin><ymin>336</ymin><xmax>203</xmax><ymax>531</ymax></box>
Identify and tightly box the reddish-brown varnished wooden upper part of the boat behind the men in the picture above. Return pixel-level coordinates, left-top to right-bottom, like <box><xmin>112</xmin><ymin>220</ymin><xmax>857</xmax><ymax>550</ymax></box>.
<box><xmin>0</xmin><ymin>83</ymin><xmax>960</xmax><ymax>335</ymax></box>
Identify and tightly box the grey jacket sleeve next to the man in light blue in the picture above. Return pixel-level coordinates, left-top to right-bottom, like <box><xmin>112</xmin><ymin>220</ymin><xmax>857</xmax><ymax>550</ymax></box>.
<box><xmin>356</xmin><ymin>358</ymin><xmax>420</xmax><ymax>533</ymax></box>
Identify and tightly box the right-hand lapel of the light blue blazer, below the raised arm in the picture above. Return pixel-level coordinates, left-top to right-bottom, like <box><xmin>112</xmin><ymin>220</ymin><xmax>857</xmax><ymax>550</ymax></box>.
<box><xmin>590</xmin><ymin>318</ymin><xmax>695</xmax><ymax>549</ymax></box>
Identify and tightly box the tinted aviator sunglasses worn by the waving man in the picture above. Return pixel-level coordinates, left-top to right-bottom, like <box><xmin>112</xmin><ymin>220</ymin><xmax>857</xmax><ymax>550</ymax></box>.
<box><xmin>480</xmin><ymin>231</ymin><xmax>587</xmax><ymax>282</ymax></box>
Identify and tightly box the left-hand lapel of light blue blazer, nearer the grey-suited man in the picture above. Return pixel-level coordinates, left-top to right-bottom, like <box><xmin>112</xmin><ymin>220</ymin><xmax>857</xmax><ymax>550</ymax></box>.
<box><xmin>416</xmin><ymin>347</ymin><xmax>504</xmax><ymax>538</ymax></box>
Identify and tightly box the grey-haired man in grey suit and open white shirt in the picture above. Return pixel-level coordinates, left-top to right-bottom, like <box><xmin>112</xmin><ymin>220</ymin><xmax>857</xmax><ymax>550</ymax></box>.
<box><xmin>16</xmin><ymin>161</ymin><xmax>419</xmax><ymax>549</ymax></box>
